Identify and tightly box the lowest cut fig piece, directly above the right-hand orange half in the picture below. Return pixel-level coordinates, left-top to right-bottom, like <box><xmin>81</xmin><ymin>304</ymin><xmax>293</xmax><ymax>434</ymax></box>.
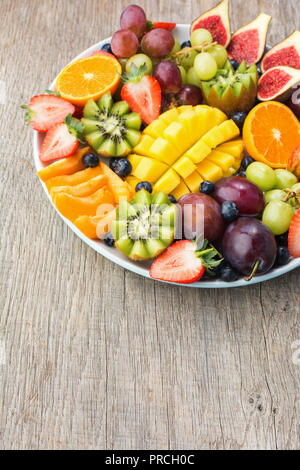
<box><xmin>257</xmin><ymin>66</ymin><xmax>300</xmax><ymax>101</ymax></box>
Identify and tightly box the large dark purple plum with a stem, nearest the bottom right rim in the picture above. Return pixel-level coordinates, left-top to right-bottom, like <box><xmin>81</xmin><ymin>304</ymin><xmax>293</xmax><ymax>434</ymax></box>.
<box><xmin>222</xmin><ymin>217</ymin><xmax>277</xmax><ymax>276</ymax></box>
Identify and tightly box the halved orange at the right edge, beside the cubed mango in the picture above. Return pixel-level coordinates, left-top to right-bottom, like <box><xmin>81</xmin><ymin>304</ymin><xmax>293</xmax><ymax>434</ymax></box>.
<box><xmin>243</xmin><ymin>101</ymin><xmax>300</xmax><ymax>168</ymax></box>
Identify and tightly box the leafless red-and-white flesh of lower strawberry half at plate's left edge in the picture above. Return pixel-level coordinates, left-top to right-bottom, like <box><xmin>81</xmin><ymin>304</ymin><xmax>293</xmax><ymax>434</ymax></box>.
<box><xmin>40</xmin><ymin>123</ymin><xmax>79</xmax><ymax>163</ymax></box>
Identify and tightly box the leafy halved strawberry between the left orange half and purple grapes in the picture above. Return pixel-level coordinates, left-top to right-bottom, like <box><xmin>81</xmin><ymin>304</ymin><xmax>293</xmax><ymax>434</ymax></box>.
<box><xmin>121</xmin><ymin>64</ymin><xmax>161</xmax><ymax>124</ymax></box>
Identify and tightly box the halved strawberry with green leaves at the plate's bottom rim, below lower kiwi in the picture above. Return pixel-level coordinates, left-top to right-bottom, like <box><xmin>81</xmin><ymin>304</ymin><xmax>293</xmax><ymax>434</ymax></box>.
<box><xmin>150</xmin><ymin>240</ymin><xmax>222</xmax><ymax>284</ymax></box>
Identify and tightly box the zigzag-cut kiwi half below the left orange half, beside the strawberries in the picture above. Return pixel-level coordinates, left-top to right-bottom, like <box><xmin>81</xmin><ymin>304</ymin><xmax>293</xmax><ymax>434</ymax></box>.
<box><xmin>82</xmin><ymin>93</ymin><xmax>142</xmax><ymax>157</ymax></box>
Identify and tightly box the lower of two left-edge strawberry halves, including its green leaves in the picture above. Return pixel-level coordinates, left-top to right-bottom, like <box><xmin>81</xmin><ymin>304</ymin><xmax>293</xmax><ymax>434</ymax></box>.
<box><xmin>40</xmin><ymin>114</ymin><xmax>83</xmax><ymax>163</ymax></box>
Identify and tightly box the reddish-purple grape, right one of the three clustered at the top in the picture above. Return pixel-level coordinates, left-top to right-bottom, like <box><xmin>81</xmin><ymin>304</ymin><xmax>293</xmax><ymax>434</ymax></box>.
<box><xmin>141</xmin><ymin>28</ymin><xmax>175</xmax><ymax>59</ymax></box>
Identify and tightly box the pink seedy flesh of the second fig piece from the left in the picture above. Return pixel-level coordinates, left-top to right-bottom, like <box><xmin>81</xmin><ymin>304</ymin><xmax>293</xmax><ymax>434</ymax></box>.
<box><xmin>228</xmin><ymin>29</ymin><xmax>259</xmax><ymax>66</ymax></box>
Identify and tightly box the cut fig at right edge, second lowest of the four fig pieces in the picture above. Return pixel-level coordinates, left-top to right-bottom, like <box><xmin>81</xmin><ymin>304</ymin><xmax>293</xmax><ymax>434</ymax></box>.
<box><xmin>261</xmin><ymin>31</ymin><xmax>300</xmax><ymax>73</ymax></box>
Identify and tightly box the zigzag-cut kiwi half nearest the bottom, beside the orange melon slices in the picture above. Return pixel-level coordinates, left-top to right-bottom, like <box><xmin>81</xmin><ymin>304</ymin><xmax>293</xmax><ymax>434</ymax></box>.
<box><xmin>111</xmin><ymin>189</ymin><xmax>177</xmax><ymax>261</ymax></box>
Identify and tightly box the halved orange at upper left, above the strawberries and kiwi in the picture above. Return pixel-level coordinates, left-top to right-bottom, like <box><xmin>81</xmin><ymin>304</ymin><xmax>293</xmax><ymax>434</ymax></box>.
<box><xmin>56</xmin><ymin>55</ymin><xmax>122</xmax><ymax>106</ymax></box>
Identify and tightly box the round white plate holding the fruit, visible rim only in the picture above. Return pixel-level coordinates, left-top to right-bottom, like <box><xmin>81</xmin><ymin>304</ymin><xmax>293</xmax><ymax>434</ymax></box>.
<box><xmin>33</xmin><ymin>24</ymin><xmax>300</xmax><ymax>289</ymax></box>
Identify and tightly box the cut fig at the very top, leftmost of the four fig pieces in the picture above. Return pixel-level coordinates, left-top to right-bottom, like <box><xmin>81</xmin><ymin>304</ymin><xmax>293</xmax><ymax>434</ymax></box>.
<box><xmin>191</xmin><ymin>0</ymin><xmax>231</xmax><ymax>47</ymax></box>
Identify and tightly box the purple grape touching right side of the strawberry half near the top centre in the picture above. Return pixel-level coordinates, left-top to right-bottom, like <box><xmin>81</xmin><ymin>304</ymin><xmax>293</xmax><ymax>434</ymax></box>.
<box><xmin>153</xmin><ymin>60</ymin><xmax>182</xmax><ymax>95</ymax></box>
